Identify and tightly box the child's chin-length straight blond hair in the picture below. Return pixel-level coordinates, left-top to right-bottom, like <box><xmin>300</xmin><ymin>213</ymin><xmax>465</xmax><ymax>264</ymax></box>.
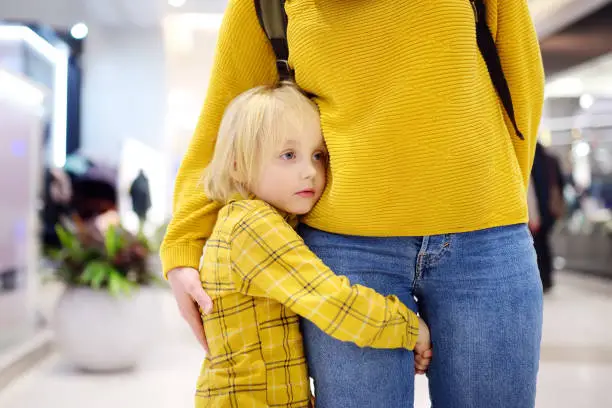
<box><xmin>203</xmin><ymin>83</ymin><xmax>320</xmax><ymax>203</ymax></box>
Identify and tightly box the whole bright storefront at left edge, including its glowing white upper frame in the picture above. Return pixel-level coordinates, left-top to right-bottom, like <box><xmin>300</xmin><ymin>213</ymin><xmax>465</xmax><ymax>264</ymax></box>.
<box><xmin>0</xmin><ymin>24</ymin><xmax>68</xmax><ymax>352</ymax></box>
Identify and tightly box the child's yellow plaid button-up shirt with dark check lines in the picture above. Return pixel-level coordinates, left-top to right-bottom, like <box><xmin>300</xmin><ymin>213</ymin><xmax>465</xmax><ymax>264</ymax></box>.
<box><xmin>196</xmin><ymin>200</ymin><xmax>418</xmax><ymax>408</ymax></box>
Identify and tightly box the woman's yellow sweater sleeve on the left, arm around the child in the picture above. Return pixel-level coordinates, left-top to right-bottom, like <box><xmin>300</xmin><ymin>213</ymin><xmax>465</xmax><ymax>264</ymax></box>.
<box><xmin>160</xmin><ymin>0</ymin><xmax>277</xmax><ymax>276</ymax></box>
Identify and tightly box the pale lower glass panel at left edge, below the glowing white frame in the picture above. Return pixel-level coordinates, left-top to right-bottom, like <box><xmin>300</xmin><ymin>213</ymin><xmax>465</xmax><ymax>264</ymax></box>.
<box><xmin>0</xmin><ymin>68</ymin><xmax>45</xmax><ymax>351</ymax></box>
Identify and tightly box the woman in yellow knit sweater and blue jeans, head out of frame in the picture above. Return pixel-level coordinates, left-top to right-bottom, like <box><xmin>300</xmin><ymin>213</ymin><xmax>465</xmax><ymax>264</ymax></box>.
<box><xmin>162</xmin><ymin>0</ymin><xmax>543</xmax><ymax>408</ymax></box>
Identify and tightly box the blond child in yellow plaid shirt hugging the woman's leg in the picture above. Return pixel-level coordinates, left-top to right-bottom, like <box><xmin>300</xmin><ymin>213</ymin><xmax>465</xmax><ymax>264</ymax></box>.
<box><xmin>196</xmin><ymin>84</ymin><xmax>431</xmax><ymax>407</ymax></box>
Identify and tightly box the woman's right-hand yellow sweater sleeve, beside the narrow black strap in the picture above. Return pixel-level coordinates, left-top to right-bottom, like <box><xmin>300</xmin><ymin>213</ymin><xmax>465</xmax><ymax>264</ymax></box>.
<box><xmin>492</xmin><ymin>0</ymin><xmax>544</xmax><ymax>186</ymax></box>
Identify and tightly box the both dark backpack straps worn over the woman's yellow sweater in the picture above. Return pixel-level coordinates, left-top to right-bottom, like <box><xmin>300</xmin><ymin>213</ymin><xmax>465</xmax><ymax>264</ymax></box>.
<box><xmin>255</xmin><ymin>0</ymin><xmax>525</xmax><ymax>140</ymax></box>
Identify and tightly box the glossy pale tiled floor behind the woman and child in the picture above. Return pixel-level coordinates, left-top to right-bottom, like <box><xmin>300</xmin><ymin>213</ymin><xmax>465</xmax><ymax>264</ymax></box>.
<box><xmin>0</xmin><ymin>274</ymin><xmax>612</xmax><ymax>408</ymax></box>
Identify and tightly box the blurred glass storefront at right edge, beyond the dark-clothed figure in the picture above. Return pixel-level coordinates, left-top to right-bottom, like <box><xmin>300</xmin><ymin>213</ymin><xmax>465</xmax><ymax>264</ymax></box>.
<box><xmin>548</xmin><ymin>126</ymin><xmax>612</xmax><ymax>277</ymax></box>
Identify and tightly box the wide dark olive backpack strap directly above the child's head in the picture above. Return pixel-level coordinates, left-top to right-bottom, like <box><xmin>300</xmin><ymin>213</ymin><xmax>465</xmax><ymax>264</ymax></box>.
<box><xmin>255</xmin><ymin>0</ymin><xmax>293</xmax><ymax>81</ymax></box>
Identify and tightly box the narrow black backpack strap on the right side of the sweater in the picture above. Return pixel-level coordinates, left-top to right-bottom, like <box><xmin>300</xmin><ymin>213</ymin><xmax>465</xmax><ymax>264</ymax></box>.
<box><xmin>470</xmin><ymin>0</ymin><xmax>525</xmax><ymax>140</ymax></box>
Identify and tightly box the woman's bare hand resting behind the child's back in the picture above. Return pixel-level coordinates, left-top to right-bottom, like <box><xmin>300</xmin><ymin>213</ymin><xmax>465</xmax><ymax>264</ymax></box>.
<box><xmin>168</xmin><ymin>268</ymin><xmax>212</xmax><ymax>352</ymax></box>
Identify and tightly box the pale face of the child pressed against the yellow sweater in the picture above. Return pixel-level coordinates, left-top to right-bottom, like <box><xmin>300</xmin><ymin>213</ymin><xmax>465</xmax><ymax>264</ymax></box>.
<box><xmin>251</xmin><ymin>127</ymin><xmax>327</xmax><ymax>215</ymax></box>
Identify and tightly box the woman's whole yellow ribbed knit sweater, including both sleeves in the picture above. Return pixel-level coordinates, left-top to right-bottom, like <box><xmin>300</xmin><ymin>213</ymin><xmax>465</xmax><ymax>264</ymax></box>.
<box><xmin>162</xmin><ymin>0</ymin><xmax>543</xmax><ymax>271</ymax></box>
